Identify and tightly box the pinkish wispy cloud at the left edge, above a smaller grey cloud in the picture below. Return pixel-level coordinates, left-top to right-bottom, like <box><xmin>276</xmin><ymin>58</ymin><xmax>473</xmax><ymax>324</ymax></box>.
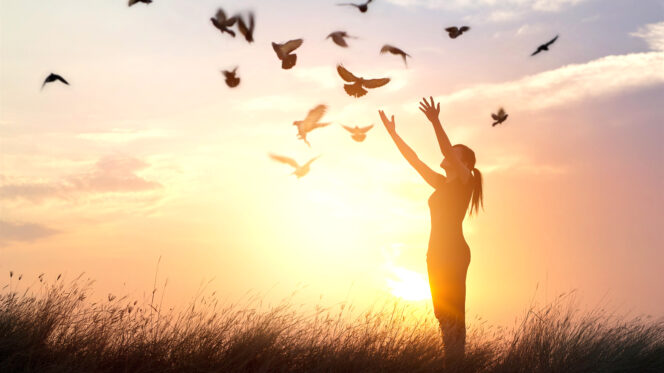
<box><xmin>0</xmin><ymin>156</ymin><xmax>162</xmax><ymax>202</ymax></box>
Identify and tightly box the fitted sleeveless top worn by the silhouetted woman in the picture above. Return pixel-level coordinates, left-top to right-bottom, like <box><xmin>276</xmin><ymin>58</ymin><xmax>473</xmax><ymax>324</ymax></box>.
<box><xmin>427</xmin><ymin>178</ymin><xmax>473</xmax><ymax>262</ymax></box>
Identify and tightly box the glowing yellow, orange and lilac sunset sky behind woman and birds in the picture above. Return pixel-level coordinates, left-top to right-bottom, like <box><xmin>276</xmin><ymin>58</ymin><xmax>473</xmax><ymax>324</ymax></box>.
<box><xmin>0</xmin><ymin>0</ymin><xmax>664</xmax><ymax>323</ymax></box>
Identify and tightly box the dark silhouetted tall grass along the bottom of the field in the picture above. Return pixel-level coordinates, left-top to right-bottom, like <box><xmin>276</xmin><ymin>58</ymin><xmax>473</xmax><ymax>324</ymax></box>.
<box><xmin>0</xmin><ymin>276</ymin><xmax>664</xmax><ymax>373</ymax></box>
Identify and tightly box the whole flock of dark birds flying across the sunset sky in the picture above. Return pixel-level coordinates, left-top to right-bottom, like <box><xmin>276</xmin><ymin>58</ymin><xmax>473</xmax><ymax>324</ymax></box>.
<box><xmin>42</xmin><ymin>0</ymin><xmax>558</xmax><ymax>178</ymax></box>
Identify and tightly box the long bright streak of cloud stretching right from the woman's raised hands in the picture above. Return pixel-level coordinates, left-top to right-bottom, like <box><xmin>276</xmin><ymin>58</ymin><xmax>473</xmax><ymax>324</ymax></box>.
<box><xmin>426</xmin><ymin>52</ymin><xmax>664</xmax><ymax>112</ymax></box>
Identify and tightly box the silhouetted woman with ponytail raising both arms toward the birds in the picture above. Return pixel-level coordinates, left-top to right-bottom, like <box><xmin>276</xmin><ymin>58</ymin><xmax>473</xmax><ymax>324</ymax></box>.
<box><xmin>379</xmin><ymin>97</ymin><xmax>482</xmax><ymax>359</ymax></box>
